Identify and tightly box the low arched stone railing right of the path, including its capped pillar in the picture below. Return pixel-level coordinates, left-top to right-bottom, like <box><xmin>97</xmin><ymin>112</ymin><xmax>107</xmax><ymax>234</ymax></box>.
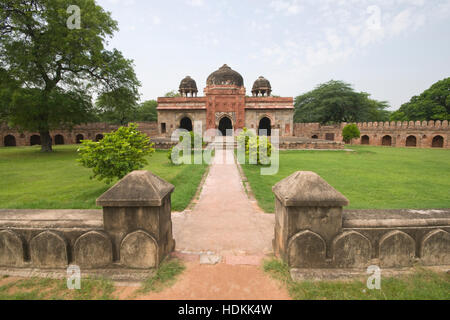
<box><xmin>273</xmin><ymin>172</ymin><xmax>450</xmax><ymax>269</ymax></box>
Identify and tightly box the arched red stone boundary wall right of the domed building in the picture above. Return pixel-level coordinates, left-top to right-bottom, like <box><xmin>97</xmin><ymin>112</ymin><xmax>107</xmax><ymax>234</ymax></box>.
<box><xmin>294</xmin><ymin>121</ymin><xmax>450</xmax><ymax>148</ymax></box>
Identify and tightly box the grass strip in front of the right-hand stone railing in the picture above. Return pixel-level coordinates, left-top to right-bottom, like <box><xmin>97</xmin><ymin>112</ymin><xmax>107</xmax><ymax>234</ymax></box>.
<box><xmin>264</xmin><ymin>259</ymin><xmax>450</xmax><ymax>300</ymax></box>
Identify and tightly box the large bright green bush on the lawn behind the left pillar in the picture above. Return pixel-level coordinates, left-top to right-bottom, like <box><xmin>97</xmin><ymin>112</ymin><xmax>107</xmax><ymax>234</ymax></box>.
<box><xmin>78</xmin><ymin>123</ymin><xmax>155</xmax><ymax>184</ymax></box>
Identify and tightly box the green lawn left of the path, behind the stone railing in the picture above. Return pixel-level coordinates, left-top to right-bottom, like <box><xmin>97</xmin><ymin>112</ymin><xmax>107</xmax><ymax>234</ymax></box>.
<box><xmin>0</xmin><ymin>146</ymin><xmax>207</xmax><ymax>211</ymax></box>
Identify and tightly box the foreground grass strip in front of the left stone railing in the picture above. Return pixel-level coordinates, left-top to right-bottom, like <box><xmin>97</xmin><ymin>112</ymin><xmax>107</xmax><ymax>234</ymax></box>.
<box><xmin>0</xmin><ymin>278</ymin><xmax>115</xmax><ymax>300</ymax></box>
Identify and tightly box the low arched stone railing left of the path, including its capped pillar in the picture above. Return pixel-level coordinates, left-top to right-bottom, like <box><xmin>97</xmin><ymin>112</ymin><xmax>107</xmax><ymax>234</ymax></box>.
<box><xmin>0</xmin><ymin>171</ymin><xmax>175</xmax><ymax>272</ymax></box>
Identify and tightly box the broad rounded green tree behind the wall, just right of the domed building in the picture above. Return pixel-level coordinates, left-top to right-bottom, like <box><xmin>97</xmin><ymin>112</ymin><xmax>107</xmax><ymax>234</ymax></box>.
<box><xmin>295</xmin><ymin>80</ymin><xmax>389</xmax><ymax>124</ymax></box>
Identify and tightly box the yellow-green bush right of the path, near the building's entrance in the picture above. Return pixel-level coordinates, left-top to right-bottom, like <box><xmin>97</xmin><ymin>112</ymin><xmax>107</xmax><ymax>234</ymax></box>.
<box><xmin>237</xmin><ymin>128</ymin><xmax>272</xmax><ymax>165</ymax></box>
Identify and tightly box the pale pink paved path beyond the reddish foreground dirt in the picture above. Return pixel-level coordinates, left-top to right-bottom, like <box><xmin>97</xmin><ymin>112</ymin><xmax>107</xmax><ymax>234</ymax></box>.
<box><xmin>172</xmin><ymin>150</ymin><xmax>274</xmax><ymax>260</ymax></box>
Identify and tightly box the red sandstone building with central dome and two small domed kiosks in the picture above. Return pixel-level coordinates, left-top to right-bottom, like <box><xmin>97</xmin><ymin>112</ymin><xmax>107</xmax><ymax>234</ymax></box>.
<box><xmin>158</xmin><ymin>64</ymin><xmax>294</xmax><ymax>137</ymax></box>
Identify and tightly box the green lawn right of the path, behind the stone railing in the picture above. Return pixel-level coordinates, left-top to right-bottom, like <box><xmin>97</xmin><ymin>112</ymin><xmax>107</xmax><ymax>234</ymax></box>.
<box><xmin>242</xmin><ymin>146</ymin><xmax>450</xmax><ymax>212</ymax></box>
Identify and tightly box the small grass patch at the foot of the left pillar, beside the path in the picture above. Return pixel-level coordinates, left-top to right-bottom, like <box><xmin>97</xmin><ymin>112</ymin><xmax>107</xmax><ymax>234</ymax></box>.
<box><xmin>137</xmin><ymin>258</ymin><xmax>185</xmax><ymax>294</ymax></box>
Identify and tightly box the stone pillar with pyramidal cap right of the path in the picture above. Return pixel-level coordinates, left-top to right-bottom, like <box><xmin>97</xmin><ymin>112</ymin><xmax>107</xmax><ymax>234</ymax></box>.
<box><xmin>273</xmin><ymin>171</ymin><xmax>349</xmax><ymax>268</ymax></box>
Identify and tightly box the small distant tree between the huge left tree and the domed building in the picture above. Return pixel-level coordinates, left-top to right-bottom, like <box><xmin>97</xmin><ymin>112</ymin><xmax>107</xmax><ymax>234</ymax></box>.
<box><xmin>96</xmin><ymin>88</ymin><xmax>138</xmax><ymax>125</ymax></box>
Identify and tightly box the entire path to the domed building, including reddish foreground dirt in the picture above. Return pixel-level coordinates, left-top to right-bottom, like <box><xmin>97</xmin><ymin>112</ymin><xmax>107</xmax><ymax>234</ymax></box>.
<box><xmin>126</xmin><ymin>150</ymin><xmax>289</xmax><ymax>300</ymax></box>
